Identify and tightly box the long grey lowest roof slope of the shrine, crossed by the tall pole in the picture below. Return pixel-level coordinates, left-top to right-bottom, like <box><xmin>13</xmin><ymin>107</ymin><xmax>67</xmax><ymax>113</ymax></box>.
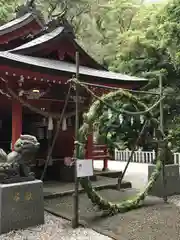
<box><xmin>0</xmin><ymin>52</ymin><xmax>148</xmax><ymax>84</ymax></box>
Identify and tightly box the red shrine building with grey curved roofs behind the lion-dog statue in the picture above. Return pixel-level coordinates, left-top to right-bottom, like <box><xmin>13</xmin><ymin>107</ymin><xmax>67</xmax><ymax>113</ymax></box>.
<box><xmin>0</xmin><ymin>2</ymin><xmax>147</xmax><ymax>180</ymax></box>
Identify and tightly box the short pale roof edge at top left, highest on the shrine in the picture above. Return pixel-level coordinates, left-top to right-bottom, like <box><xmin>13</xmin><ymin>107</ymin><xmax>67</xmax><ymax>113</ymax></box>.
<box><xmin>0</xmin><ymin>13</ymin><xmax>40</xmax><ymax>36</ymax></box>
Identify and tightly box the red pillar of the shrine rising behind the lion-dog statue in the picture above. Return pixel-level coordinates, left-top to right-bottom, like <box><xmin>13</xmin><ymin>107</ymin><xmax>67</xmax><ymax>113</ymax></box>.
<box><xmin>11</xmin><ymin>100</ymin><xmax>22</xmax><ymax>150</ymax></box>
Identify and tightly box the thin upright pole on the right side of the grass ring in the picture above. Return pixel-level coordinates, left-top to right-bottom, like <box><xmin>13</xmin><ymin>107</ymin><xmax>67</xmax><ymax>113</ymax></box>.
<box><xmin>159</xmin><ymin>75</ymin><xmax>167</xmax><ymax>202</ymax></box>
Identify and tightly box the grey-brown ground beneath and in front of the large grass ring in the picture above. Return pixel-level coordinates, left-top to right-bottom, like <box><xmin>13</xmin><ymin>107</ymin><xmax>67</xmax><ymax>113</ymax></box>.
<box><xmin>45</xmin><ymin>189</ymin><xmax>180</xmax><ymax>240</ymax></box>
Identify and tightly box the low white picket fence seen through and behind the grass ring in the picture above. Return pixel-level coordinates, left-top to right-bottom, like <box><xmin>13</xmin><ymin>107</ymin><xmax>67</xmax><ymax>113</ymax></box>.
<box><xmin>115</xmin><ymin>149</ymin><xmax>180</xmax><ymax>165</ymax></box>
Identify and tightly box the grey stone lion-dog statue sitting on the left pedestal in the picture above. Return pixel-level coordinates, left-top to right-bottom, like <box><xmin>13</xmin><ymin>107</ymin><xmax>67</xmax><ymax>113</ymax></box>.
<box><xmin>0</xmin><ymin>135</ymin><xmax>40</xmax><ymax>183</ymax></box>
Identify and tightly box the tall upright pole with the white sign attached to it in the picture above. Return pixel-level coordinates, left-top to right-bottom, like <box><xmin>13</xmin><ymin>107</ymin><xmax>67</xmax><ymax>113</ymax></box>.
<box><xmin>72</xmin><ymin>52</ymin><xmax>79</xmax><ymax>228</ymax></box>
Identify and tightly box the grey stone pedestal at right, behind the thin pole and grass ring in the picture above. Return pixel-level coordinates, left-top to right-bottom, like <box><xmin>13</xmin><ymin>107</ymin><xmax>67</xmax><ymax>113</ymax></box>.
<box><xmin>148</xmin><ymin>164</ymin><xmax>180</xmax><ymax>197</ymax></box>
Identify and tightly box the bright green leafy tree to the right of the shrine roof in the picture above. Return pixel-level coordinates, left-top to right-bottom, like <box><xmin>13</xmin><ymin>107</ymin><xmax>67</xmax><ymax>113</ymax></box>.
<box><xmin>96</xmin><ymin>1</ymin><xmax>180</xmax><ymax>148</ymax></box>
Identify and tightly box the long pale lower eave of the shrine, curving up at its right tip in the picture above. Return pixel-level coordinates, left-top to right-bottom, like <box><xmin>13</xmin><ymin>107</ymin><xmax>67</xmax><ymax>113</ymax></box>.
<box><xmin>0</xmin><ymin>52</ymin><xmax>148</xmax><ymax>85</ymax></box>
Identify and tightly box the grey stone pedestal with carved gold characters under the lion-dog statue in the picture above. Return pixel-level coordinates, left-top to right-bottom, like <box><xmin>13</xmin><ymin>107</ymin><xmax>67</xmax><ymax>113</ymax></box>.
<box><xmin>0</xmin><ymin>180</ymin><xmax>44</xmax><ymax>234</ymax></box>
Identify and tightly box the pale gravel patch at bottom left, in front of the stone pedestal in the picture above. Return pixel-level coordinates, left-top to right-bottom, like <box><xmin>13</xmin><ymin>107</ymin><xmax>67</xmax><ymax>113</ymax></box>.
<box><xmin>0</xmin><ymin>213</ymin><xmax>111</xmax><ymax>240</ymax></box>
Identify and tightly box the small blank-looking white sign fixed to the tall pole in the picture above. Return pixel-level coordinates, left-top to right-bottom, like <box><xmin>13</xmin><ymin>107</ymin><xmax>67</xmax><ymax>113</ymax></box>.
<box><xmin>76</xmin><ymin>159</ymin><xmax>93</xmax><ymax>178</ymax></box>
